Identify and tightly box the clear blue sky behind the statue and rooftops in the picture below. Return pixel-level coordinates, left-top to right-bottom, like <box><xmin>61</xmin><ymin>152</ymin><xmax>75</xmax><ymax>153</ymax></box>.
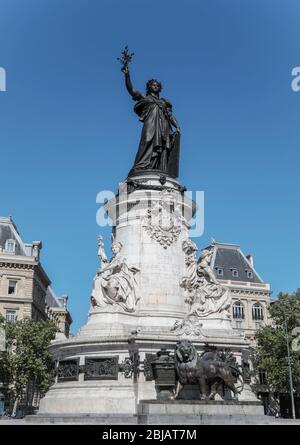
<box><xmin>0</xmin><ymin>0</ymin><xmax>300</xmax><ymax>332</ymax></box>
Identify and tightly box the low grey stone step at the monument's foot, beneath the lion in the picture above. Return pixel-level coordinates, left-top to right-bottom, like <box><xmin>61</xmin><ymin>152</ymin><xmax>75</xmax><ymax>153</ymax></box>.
<box><xmin>26</xmin><ymin>400</ymin><xmax>275</xmax><ymax>425</ymax></box>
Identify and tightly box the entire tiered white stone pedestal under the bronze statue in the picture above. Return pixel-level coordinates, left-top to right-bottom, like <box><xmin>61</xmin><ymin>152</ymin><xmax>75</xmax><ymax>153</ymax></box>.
<box><xmin>39</xmin><ymin>173</ymin><xmax>258</xmax><ymax>416</ymax></box>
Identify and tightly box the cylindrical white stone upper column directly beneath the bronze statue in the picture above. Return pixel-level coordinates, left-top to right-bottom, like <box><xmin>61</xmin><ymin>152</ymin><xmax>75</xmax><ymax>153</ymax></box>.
<box><xmin>80</xmin><ymin>174</ymin><xmax>193</xmax><ymax>336</ymax></box>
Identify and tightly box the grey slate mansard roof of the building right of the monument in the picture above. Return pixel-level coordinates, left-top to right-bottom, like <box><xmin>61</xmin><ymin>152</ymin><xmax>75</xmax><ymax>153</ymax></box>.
<box><xmin>203</xmin><ymin>241</ymin><xmax>264</xmax><ymax>283</ymax></box>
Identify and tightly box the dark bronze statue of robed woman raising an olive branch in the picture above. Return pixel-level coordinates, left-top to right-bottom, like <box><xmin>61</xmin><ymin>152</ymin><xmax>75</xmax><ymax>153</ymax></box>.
<box><xmin>119</xmin><ymin>47</ymin><xmax>180</xmax><ymax>178</ymax></box>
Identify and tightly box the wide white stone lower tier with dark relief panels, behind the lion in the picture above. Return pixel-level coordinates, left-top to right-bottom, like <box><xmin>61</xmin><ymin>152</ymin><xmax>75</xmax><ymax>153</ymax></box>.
<box><xmin>39</xmin><ymin>330</ymin><xmax>247</xmax><ymax>416</ymax></box>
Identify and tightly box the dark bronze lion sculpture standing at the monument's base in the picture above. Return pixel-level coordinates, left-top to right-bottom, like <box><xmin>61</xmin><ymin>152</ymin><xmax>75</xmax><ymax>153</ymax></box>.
<box><xmin>174</xmin><ymin>340</ymin><xmax>243</xmax><ymax>400</ymax></box>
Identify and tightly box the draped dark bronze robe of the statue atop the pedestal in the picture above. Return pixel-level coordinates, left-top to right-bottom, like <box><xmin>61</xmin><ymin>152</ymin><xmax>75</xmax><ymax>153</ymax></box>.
<box><xmin>133</xmin><ymin>94</ymin><xmax>179</xmax><ymax>177</ymax></box>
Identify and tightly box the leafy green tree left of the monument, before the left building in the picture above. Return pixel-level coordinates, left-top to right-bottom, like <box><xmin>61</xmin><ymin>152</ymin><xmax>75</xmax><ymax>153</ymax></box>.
<box><xmin>0</xmin><ymin>318</ymin><xmax>57</xmax><ymax>411</ymax></box>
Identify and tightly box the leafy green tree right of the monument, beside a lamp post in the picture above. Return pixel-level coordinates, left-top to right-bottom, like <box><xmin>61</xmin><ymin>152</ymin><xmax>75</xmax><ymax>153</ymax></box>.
<box><xmin>256</xmin><ymin>289</ymin><xmax>300</xmax><ymax>393</ymax></box>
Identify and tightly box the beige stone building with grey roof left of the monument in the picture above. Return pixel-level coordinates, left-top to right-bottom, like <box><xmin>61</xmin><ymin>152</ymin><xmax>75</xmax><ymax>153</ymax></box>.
<box><xmin>0</xmin><ymin>217</ymin><xmax>72</xmax><ymax>337</ymax></box>
